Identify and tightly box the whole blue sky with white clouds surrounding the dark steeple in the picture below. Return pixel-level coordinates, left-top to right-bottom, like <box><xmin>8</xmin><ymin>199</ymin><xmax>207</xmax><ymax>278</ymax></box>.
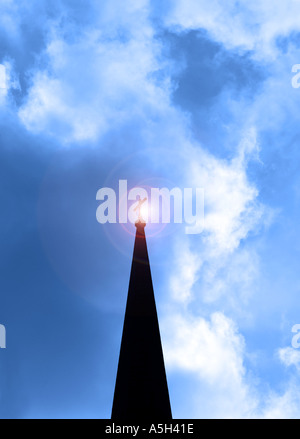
<box><xmin>0</xmin><ymin>0</ymin><xmax>300</xmax><ymax>418</ymax></box>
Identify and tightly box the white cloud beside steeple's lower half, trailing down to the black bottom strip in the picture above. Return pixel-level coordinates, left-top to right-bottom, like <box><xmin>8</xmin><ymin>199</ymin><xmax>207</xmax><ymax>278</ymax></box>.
<box><xmin>163</xmin><ymin>313</ymin><xmax>257</xmax><ymax>418</ymax></box>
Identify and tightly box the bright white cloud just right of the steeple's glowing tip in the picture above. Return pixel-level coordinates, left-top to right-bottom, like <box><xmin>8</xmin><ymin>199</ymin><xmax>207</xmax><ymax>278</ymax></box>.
<box><xmin>190</xmin><ymin>132</ymin><xmax>263</xmax><ymax>256</ymax></box>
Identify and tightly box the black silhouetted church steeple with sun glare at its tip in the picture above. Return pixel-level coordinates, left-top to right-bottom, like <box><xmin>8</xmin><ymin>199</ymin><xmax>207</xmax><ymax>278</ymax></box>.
<box><xmin>111</xmin><ymin>222</ymin><xmax>172</xmax><ymax>421</ymax></box>
